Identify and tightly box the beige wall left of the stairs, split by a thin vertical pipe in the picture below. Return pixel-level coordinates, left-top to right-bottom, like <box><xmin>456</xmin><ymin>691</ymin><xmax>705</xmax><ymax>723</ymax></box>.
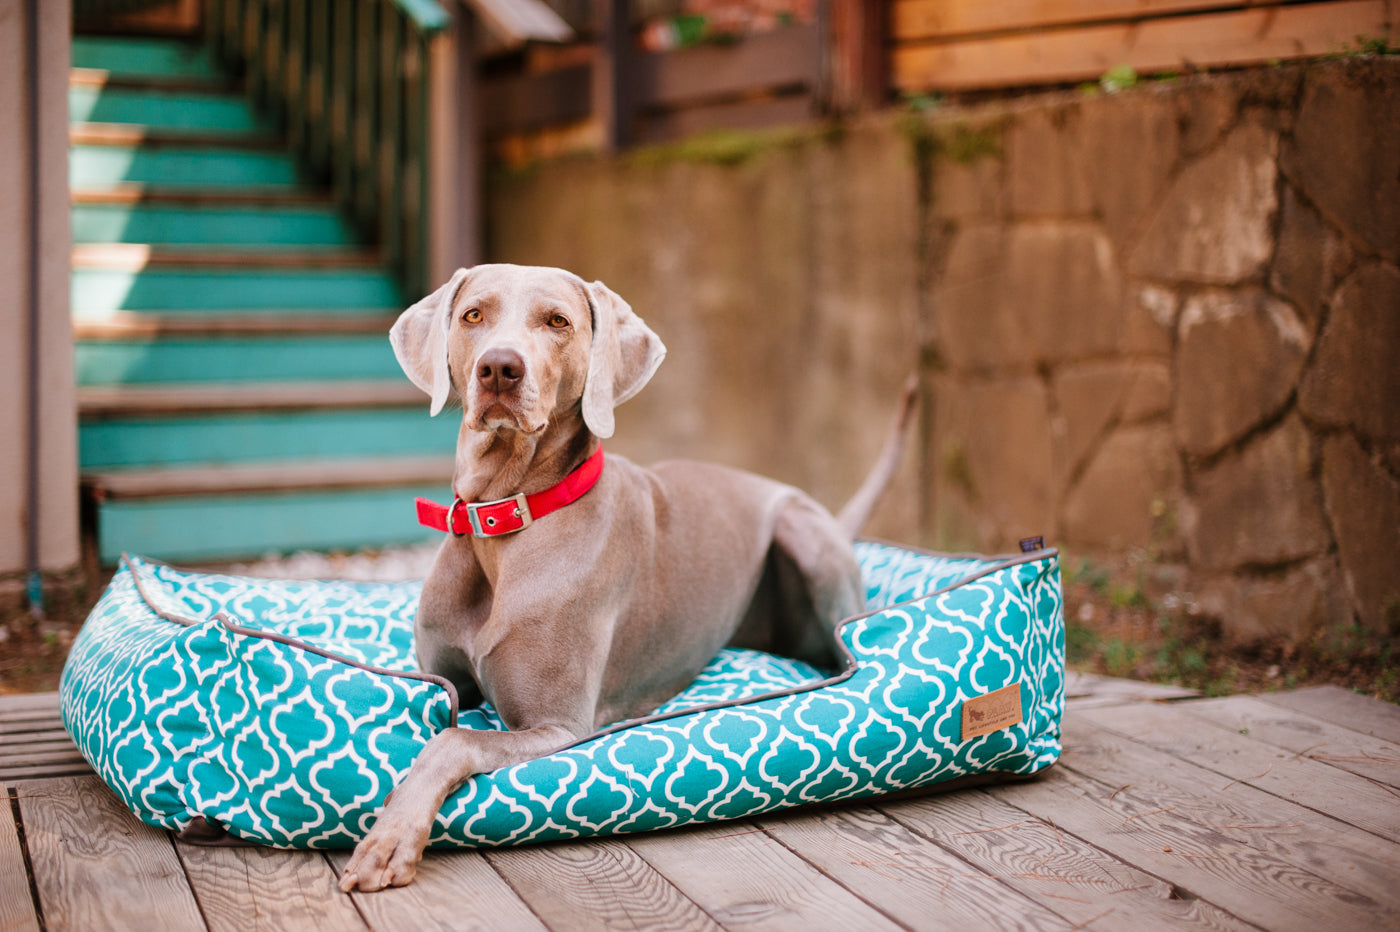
<box><xmin>0</xmin><ymin>0</ymin><xmax>78</xmax><ymax>582</ymax></box>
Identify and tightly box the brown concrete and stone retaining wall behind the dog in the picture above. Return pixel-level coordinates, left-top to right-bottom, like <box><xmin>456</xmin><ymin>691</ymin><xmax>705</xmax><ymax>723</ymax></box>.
<box><xmin>489</xmin><ymin>57</ymin><xmax>1400</xmax><ymax>640</ymax></box>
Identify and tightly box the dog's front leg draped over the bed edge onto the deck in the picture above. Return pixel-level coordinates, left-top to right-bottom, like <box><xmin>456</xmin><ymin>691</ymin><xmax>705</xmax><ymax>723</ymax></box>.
<box><xmin>340</xmin><ymin>725</ymin><xmax>580</xmax><ymax>893</ymax></box>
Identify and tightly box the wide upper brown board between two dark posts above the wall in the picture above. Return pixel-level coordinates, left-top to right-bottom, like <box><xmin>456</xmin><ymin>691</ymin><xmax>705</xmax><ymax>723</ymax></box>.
<box><xmin>631</xmin><ymin>24</ymin><xmax>820</xmax><ymax>109</ymax></box>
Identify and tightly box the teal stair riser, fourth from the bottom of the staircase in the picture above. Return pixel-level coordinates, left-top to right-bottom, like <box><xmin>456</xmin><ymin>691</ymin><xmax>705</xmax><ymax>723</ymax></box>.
<box><xmin>71</xmin><ymin>269</ymin><xmax>403</xmax><ymax>313</ymax></box>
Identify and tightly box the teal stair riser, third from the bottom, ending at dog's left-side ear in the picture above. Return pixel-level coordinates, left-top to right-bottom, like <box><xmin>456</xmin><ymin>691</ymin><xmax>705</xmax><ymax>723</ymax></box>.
<box><xmin>74</xmin><ymin>333</ymin><xmax>403</xmax><ymax>386</ymax></box>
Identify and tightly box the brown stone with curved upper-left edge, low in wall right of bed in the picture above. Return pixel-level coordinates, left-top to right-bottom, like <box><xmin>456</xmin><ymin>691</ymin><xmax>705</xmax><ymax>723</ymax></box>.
<box><xmin>1060</xmin><ymin>424</ymin><xmax>1182</xmax><ymax>553</ymax></box>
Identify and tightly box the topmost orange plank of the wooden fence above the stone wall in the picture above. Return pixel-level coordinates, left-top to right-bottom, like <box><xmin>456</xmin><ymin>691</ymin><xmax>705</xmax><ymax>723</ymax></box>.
<box><xmin>890</xmin><ymin>0</ymin><xmax>1284</xmax><ymax>42</ymax></box>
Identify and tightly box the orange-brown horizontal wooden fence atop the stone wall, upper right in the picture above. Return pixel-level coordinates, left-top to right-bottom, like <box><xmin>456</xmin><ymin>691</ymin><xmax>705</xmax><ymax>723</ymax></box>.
<box><xmin>889</xmin><ymin>0</ymin><xmax>1400</xmax><ymax>92</ymax></box>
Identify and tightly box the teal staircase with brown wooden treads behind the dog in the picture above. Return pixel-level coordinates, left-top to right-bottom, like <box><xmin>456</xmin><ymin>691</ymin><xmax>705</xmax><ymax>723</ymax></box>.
<box><xmin>69</xmin><ymin>36</ymin><xmax>456</xmax><ymax>564</ymax></box>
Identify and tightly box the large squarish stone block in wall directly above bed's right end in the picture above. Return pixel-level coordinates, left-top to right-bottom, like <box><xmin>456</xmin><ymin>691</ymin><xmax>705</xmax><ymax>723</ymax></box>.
<box><xmin>927</xmin><ymin>376</ymin><xmax>1053</xmax><ymax>550</ymax></box>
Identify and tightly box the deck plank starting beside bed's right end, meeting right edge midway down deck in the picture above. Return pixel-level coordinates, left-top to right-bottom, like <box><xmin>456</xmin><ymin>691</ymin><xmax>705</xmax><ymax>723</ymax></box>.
<box><xmin>1084</xmin><ymin>707</ymin><xmax>1400</xmax><ymax>841</ymax></box>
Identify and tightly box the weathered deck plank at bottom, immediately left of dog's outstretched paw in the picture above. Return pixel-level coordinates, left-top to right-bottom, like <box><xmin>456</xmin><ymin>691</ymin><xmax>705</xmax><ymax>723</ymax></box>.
<box><xmin>175</xmin><ymin>841</ymin><xmax>365</xmax><ymax>932</ymax></box>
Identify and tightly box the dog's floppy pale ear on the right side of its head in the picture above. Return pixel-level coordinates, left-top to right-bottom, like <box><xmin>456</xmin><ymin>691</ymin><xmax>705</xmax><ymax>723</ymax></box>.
<box><xmin>584</xmin><ymin>281</ymin><xmax>666</xmax><ymax>437</ymax></box>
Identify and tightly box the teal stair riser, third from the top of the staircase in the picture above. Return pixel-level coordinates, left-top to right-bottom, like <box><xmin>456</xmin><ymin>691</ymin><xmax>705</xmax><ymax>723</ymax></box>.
<box><xmin>69</xmin><ymin>146</ymin><xmax>301</xmax><ymax>190</ymax></box>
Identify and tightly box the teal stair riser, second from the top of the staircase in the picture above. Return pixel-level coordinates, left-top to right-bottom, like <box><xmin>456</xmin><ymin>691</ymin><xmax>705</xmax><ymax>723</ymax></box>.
<box><xmin>69</xmin><ymin>85</ymin><xmax>272</xmax><ymax>133</ymax></box>
